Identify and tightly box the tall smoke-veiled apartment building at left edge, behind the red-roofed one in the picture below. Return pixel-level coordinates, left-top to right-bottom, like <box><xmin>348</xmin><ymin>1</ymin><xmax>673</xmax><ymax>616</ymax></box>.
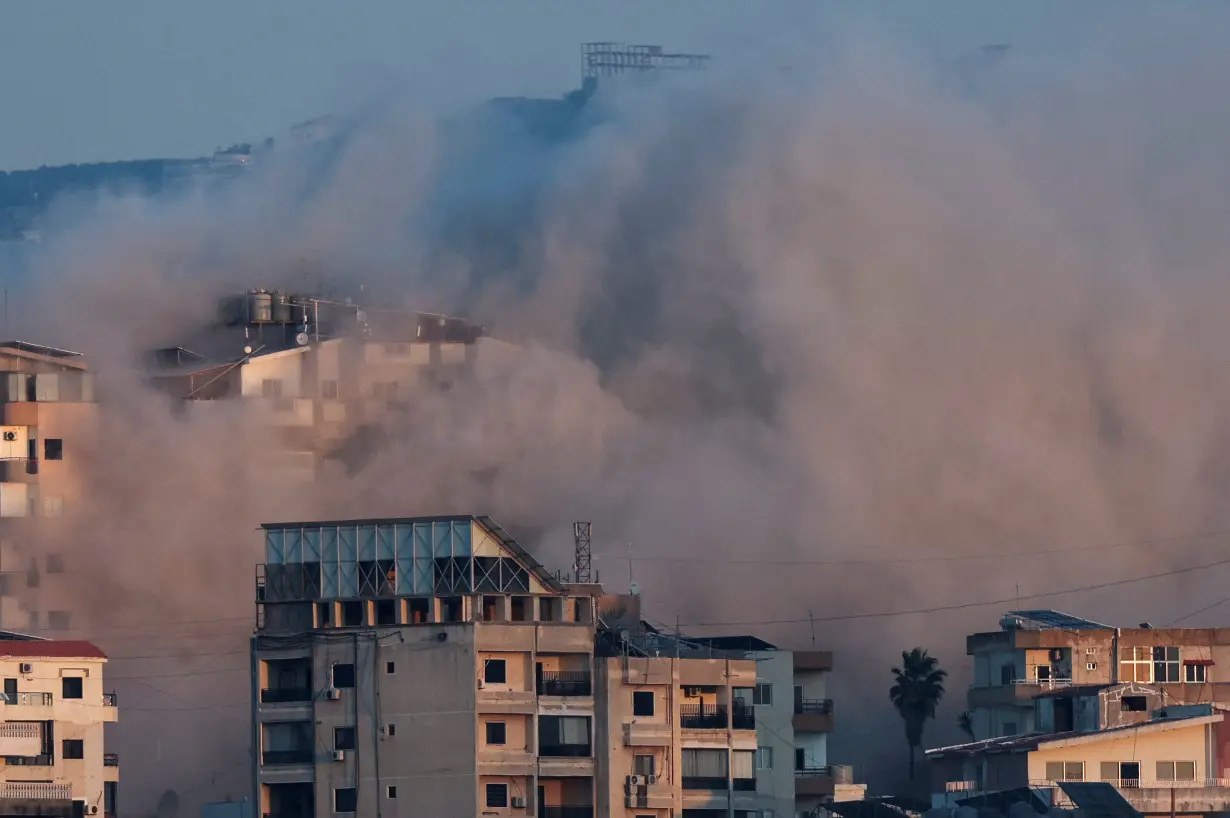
<box><xmin>0</xmin><ymin>341</ymin><xmax>97</xmax><ymax>630</ymax></box>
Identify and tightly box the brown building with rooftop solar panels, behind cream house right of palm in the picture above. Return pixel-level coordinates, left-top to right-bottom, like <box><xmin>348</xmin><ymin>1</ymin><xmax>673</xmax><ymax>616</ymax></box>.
<box><xmin>966</xmin><ymin>610</ymin><xmax>1230</xmax><ymax>739</ymax></box>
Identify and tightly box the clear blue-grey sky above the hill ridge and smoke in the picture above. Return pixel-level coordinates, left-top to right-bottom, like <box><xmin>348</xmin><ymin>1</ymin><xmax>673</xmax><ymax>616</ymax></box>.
<box><xmin>0</xmin><ymin>0</ymin><xmax>1125</xmax><ymax>170</ymax></box>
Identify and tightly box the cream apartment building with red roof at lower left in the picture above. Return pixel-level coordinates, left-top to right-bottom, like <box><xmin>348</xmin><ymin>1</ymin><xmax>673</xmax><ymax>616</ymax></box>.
<box><xmin>0</xmin><ymin>631</ymin><xmax>119</xmax><ymax>816</ymax></box>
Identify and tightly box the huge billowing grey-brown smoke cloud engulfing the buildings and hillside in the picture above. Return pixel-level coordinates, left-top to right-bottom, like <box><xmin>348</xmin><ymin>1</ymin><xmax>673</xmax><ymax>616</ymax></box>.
<box><xmin>2</xmin><ymin>15</ymin><xmax>1230</xmax><ymax>802</ymax></box>
